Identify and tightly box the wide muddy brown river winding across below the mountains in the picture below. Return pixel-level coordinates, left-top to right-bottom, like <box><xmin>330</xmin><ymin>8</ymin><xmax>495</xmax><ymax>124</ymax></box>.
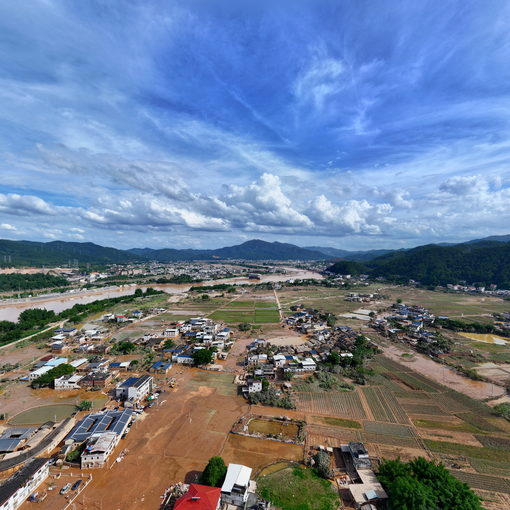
<box><xmin>0</xmin><ymin>267</ymin><xmax>322</xmax><ymax>322</ymax></box>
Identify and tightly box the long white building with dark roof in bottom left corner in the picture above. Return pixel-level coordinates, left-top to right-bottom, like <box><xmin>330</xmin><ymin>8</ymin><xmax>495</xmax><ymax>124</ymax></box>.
<box><xmin>0</xmin><ymin>458</ymin><xmax>48</xmax><ymax>510</ymax></box>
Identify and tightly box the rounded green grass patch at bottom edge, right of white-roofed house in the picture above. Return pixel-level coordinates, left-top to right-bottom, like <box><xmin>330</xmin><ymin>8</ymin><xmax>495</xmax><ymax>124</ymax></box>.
<box><xmin>257</xmin><ymin>467</ymin><xmax>339</xmax><ymax>510</ymax></box>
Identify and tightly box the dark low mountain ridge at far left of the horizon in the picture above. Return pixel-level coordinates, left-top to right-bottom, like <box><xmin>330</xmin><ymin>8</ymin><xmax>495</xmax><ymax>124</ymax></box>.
<box><xmin>0</xmin><ymin>239</ymin><xmax>140</xmax><ymax>266</ymax></box>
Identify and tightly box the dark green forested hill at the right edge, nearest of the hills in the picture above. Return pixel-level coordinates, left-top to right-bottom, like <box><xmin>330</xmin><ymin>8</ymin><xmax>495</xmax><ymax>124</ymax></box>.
<box><xmin>329</xmin><ymin>241</ymin><xmax>510</xmax><ymax>288</ymax></box>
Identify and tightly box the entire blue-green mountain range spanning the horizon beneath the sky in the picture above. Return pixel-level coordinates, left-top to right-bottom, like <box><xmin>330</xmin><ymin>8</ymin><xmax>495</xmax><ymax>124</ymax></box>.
<box><xmin>0</xmin><ymin>235</ymin><xmax>510</xmax><ymax>288</ymax></box>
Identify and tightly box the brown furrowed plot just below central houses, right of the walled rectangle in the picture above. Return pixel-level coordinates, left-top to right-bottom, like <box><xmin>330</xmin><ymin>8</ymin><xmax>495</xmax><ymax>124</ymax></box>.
<box><xmin>296</xmin><ymin>391</ymin><xmax>367</xmax><ymax>419</ymax></box>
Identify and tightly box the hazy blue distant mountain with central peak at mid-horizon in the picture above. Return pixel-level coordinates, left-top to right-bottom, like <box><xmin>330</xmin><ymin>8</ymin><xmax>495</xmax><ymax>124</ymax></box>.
<box><xmin>129</xmin><ymin>239</ymin><xmax>330</xmax><ymax>262</ymax></box>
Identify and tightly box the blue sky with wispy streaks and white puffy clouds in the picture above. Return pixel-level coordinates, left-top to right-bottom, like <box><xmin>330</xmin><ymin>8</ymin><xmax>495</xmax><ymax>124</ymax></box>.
<box><xmin>0</xmin><ymin>0</ymin><xmax>510</xmax><ymax>250</ymax></box>
